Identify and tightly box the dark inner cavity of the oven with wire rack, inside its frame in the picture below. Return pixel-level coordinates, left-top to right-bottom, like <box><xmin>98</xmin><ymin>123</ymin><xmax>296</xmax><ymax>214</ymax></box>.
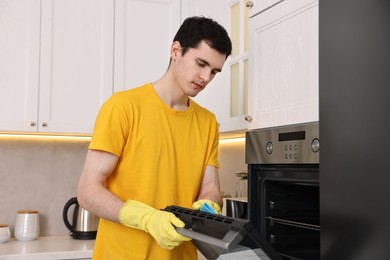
<box><xmin>263</xmin><ymin>180</ymin><xmax>320</xmax><ymax>259</ymax></box>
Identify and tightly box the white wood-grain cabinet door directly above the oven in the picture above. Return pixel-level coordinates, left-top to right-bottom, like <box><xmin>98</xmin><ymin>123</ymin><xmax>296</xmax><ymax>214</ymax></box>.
<box><xmin>248</xmin><ymin>0</ymin><xmax>319</xmax><ymax>129</ymax></box>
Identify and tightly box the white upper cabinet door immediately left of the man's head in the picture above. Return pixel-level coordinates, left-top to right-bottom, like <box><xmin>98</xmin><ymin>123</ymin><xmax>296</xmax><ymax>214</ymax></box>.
<box><xmin>114</xmin><ymin>0</ymin><xmax>181</xmax><ymax>92</ymax></box>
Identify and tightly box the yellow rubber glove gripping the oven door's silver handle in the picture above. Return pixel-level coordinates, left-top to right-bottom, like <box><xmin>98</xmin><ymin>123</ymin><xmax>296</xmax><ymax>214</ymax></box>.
<box><xmin>119</xmin><ymin>200</ymin><xmax>191</xmax><ymax>249</ymax></box>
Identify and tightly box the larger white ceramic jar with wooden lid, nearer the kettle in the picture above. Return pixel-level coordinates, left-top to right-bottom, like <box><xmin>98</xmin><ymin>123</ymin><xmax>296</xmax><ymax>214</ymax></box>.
<box><xmin>15</xmin><ymin>210</ymin><xmax>39</xmax><ymax>241</ymax></box>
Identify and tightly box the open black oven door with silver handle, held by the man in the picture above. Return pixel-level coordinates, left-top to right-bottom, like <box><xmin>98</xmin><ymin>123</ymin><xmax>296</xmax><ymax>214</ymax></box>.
<box><xmin>163</xmin><ymin>205</ymin><xmax>283</xmax><ymax>260</ymax></box>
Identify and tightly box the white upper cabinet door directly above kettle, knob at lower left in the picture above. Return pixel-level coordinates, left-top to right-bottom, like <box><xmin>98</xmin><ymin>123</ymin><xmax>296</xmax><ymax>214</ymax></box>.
<box><xmin>38</xmin><ymin>0</ymin><xmax>114</xmax><ymax>134</ymax></box>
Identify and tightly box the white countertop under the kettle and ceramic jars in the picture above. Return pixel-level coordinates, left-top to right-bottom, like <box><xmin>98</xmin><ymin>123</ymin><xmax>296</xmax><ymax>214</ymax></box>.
<box><xmin>0</xmin><ymin>236</ymin><xmax>95</xmax><ymax>260</ymax></box>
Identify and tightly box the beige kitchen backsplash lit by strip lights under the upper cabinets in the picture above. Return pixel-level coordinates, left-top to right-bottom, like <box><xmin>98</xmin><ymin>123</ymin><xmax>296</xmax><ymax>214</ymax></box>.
<box><xmin>0</xmin><ymin>136</ymin><xmax>246</xmax><ymax>236</ymax></box>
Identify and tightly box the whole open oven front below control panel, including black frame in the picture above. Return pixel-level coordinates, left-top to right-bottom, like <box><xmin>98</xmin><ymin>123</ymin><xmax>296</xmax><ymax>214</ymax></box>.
<box><xmin>249</xmin><ymin>164</ymin><xmax>320</xmax><ymax>259</ymax></box>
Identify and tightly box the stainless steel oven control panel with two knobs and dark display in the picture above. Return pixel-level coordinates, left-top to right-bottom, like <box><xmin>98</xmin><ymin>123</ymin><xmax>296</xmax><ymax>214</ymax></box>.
<box><xmin>245</xmin><ymin>122</ymin><xmax>320</xmax><ymax>164</ymax></box>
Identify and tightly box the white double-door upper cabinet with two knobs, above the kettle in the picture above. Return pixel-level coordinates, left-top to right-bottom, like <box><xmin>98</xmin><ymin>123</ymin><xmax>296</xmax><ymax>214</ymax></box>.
<box><xmin>0</xmin><ymin>0</ymin><xmax>114</xmax><ymax>134</ymax></box>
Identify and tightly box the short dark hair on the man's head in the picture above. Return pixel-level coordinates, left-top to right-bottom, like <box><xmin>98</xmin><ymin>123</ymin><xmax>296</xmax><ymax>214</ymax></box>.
<box><xmin>173</xmin><ymin>16</ymin><xmax>232</xmax><ymax>57</ymax></box>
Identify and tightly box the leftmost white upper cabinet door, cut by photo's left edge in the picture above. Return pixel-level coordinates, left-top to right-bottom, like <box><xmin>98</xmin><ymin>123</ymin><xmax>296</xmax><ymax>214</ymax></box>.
<box><xmin>0</xmin><ymin>0</ymin><xmax>40</xmax><ymax>131</ymax></box>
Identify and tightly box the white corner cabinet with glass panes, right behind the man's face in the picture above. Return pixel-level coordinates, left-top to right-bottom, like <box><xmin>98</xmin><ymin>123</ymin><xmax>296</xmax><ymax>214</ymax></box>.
<box><xmin>182</xmin><ymin>0</ymin><xmax>248</xmax><ymax>133</ymax></box>
